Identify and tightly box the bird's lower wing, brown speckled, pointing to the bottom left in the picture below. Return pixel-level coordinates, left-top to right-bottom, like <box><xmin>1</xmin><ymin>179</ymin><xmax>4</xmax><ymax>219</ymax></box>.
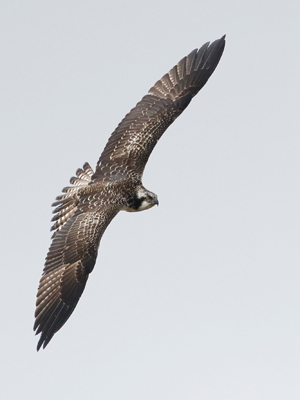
<box><xmin>34</xmin><ymin>191</ymin><xmax>120</xmax><ymax>350</ymax></box>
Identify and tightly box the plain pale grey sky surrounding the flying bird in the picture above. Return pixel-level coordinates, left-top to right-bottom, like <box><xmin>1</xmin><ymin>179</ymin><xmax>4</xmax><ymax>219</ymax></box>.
<box><xmin>0</xmin><ymin>0</ymin><xmax>300</xmax><ymax>400</ymax></box>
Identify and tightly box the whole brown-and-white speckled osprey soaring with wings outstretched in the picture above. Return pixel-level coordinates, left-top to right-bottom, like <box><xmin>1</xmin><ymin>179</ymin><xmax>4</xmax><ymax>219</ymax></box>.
<box><xmin>34</xmin><ymin>35</ymin><xmax>225</xmax><ymax>350</ymax></box>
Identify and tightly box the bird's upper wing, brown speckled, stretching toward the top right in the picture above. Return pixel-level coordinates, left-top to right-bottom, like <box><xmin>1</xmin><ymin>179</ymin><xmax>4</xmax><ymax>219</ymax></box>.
<box><xmin>92</xmin><ymin>36</ymin><xmax>225</xmax><ymax>181</ymax></box>
